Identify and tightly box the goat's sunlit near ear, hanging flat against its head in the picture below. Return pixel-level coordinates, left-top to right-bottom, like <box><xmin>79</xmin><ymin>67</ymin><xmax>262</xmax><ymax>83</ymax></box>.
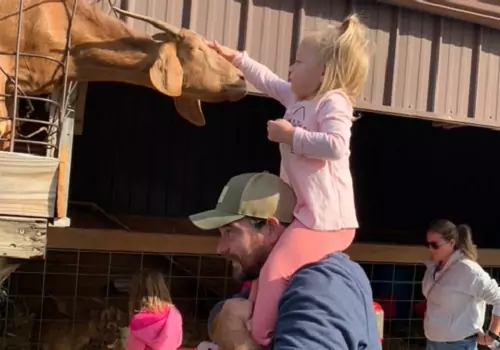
<box><xmin>149</xmin><ymin>43</ymin><xmax>184</xmax><ymax>97</ymax></box>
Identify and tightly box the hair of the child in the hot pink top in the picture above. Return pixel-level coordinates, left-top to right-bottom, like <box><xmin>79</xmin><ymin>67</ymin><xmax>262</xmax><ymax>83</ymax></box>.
<box><xmin>129</xmin><ymin>269</ymin><xmax>172</xmax><ymax>316</ymax></box>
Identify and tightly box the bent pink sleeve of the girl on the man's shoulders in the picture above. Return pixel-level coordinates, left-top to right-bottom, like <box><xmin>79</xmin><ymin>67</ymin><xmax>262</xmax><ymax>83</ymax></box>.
<box><xmin>292</xmin><ymin>92</ymin><xmax>353</xmax><ymax>160</ymax></box>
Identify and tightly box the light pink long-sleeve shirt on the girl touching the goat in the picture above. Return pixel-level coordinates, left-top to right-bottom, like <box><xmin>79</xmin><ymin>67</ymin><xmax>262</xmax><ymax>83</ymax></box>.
<box><xmin>233</xmin><ymin>52</ymin><xmax>358</xmax><ymax>231</ymax></box>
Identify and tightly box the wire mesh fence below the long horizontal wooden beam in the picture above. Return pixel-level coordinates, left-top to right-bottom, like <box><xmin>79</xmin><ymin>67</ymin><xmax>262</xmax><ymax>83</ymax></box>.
<box><xmin>0</xmin><ymin>250</ymin><xmax>500</xmax><ymax>350</ymax></box>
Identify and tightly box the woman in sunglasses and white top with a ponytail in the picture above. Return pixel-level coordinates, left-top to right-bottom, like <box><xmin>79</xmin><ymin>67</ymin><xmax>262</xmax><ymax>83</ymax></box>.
<box><xmin>422</xmin><ymin>220</ymin><xmax>500</xmax><ymax>350</ymax></box>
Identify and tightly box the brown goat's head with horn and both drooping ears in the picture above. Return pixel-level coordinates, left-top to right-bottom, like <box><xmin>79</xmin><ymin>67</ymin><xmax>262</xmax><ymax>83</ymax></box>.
<box><xmin>113</xmin><ymin>7</ymin><xmax>247</xmax><ymax>126</ymax></box>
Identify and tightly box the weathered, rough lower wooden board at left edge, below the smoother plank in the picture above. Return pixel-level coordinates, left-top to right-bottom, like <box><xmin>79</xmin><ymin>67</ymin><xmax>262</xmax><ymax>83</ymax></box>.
<box><xmin>0</xmin><ymin>216</ymin><xmax>48</xmax><ymax>259</ymax></box>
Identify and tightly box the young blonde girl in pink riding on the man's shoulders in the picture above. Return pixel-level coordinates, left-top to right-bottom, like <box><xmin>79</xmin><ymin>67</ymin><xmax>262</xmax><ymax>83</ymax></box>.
<box><xmin>208</xmin><ymin>15</ymin><xmax>369</xmax><ymax>345</ymax></box>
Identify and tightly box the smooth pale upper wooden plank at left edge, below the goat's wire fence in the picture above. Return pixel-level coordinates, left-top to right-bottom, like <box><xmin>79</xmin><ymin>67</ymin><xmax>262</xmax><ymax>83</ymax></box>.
<box><xmin>0</xmin><ymin>151</ymin><xmax>59</xmax><ymax>218</ymax></box>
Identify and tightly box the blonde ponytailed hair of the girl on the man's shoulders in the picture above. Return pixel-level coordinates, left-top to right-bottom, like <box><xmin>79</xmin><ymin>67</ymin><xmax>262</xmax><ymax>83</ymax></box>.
<box><xmin>302</xmin><ymin>14</ymin><xmax>370</xmax><ymax>103</ymax></box>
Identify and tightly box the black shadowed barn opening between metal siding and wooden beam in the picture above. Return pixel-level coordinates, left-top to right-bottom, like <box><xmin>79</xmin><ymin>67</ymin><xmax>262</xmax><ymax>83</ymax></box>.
<box><xmin>70</xmin><ymin>84</ymin><xmax>500</xmax><ymax>248</ymax></box>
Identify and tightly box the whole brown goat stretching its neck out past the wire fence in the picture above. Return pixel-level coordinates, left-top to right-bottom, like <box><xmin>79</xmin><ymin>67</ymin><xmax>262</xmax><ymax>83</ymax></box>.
<box><xmin>0</xmin><ymin>0</ymin><xmax>247</xmax><ymax>149</ymax></box>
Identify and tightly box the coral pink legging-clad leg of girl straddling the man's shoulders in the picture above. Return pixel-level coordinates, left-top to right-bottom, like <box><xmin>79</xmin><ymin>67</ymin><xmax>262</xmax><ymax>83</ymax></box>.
<box><xmin>251</xmin><ymin>220</ymin><xmax>355</xmax><ymax>346</ymax></box>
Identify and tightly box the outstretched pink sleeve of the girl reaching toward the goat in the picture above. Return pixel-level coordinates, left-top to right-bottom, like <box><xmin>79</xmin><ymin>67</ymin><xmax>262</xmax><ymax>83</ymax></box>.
<box><xmin>233</xmin><ymin>51</ymin><xmax>295</xmax><ymax>106</ymax></box>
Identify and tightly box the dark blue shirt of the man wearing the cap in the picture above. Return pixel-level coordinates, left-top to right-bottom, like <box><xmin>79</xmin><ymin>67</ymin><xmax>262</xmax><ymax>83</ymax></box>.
<box><xmin>209</xmin><ymin>253</ymin><xmax>381</xmax><ymax>350</ymax></box>
